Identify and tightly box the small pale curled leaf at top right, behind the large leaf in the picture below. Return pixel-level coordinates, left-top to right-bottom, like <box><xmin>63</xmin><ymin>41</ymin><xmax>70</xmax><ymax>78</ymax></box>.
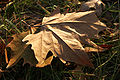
<box><xmin>80</xmin><ymin>0</ymin><xmax>105</xmax><ymax>16</ymax></box>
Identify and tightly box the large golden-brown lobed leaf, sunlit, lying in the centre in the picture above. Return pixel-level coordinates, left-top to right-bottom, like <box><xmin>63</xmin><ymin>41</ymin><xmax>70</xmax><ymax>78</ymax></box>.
<box><xmin>23</xmin><ymin>11</ymin><xmax>106</xmax><ymax>66</ymax></box>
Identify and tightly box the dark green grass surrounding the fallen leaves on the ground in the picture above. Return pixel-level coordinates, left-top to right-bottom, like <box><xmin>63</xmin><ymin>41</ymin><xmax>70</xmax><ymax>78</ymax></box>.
<box><xmin>0</xmin><ymin>0</ymin><xmax>120</xmax><ymax>80</ymax></box>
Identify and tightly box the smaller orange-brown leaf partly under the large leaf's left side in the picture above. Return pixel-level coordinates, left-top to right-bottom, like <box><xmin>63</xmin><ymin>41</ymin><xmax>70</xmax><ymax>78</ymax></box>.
<box><xmin>7</xmin><ymin>31</ymin><xmax>37</xmax><ymax>68</ymax></box>
